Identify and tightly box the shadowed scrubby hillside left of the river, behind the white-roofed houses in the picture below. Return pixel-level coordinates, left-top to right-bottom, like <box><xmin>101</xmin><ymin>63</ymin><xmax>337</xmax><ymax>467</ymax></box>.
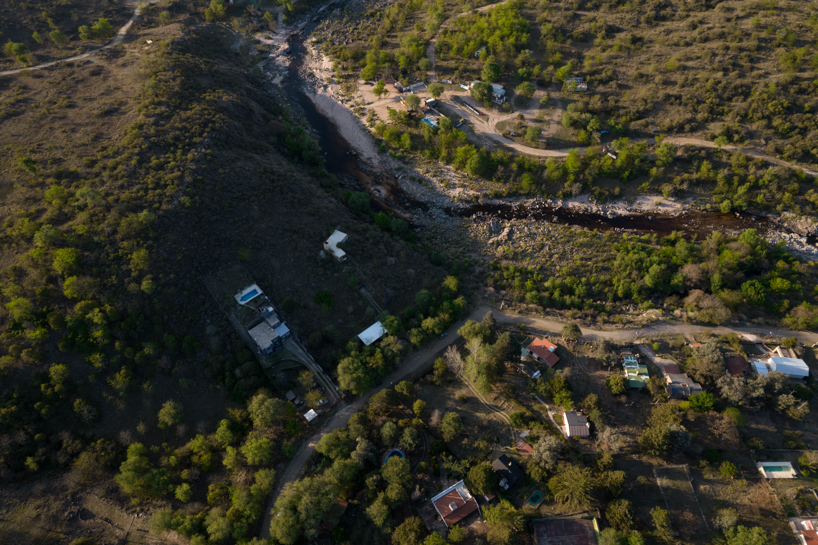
<box><xmin>0</xmin><ymin>6</ymin><xmax>446</xmax><ymax>543</ymax></box>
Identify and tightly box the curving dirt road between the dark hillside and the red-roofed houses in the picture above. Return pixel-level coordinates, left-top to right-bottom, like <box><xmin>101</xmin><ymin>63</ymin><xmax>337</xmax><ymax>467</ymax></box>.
<box><xmin>261</xmin><ymin>306</ymin><xmax>818</xmax><ymax>539</ymax></box>
